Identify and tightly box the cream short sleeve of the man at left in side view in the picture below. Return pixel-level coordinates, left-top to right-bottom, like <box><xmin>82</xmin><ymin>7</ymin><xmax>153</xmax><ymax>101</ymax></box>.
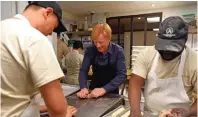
<box><xmin>25</xmin><ymin>38</ymin><xmax>64</xmax><ymax>88</ymax></box>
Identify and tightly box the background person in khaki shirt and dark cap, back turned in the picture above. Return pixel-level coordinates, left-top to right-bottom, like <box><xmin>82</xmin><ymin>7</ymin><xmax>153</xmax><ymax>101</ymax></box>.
<box><xmin>65</xmin><ymin>41</ymin><xmax>83</xmax><ymax>85</ymax></box>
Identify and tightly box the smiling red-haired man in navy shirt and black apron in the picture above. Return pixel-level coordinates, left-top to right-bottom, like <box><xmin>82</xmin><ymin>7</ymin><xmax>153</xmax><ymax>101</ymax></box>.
<box><xmin>77</xmin><ymin>24</ymin><xmax>126</xmax><ymax>98</ymax></box>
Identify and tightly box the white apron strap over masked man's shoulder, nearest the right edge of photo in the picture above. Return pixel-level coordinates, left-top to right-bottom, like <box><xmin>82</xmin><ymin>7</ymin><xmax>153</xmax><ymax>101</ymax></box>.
<box><xmin>178</xmin><ymin>49</ymin><xmax>186</xmax><ymax>77</ymax></box>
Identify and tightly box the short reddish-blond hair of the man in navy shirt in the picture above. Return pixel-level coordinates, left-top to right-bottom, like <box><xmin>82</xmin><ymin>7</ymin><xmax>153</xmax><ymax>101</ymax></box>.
<box><xmin>91</xmin><ymin>23</ymin><xmax>112</xmax><ymax>40</ymax></box>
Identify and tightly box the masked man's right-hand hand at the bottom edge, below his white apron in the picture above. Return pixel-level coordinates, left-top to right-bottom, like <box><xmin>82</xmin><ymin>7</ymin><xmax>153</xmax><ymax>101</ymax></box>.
<box><xmin>171</xmin><ymin>108</ymin><xmax>190</xmax><ymax>117</ymax></box>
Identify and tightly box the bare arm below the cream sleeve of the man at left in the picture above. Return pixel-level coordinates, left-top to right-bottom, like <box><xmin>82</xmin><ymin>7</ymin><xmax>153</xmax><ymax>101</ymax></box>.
<box><xmin>39</xmin><ymin>80</ymin><xmax>67</xmax><ymax>117</ymax></box>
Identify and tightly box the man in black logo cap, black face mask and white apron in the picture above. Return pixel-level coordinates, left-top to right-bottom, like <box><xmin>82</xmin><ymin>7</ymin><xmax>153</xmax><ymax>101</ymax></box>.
<box><xmin>129</xmin><ymin>16</ymin><xmax>197</xmax><ymax>117</ymax></box>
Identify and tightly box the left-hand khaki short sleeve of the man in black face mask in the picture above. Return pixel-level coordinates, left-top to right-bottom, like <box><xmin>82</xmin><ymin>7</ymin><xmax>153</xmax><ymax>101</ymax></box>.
<box><xmin>132</xmin><ymin>49</ymin><xmax>148</xmax><ymax>79</ymax></box>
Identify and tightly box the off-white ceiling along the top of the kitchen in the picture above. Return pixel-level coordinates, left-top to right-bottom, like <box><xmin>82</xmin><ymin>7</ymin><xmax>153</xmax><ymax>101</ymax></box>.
<box><xmin>59</xmin><ymin>1</ymin><xmax>197</xmax><ymax>17</ymax></box>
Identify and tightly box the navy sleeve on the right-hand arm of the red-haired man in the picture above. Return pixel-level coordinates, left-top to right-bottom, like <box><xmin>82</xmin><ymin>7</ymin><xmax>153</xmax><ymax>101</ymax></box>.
<box><xmin>103</xmin><ymin>49</ymin><xmax>126</xmax><ymax>92</ymax></box>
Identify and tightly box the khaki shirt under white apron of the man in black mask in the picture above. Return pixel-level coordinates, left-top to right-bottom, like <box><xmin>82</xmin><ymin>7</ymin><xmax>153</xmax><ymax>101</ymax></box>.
<box><xmin>132</xmin><ymin>46</ymin><xmax>197</xmax><ymax>101</ymax></box>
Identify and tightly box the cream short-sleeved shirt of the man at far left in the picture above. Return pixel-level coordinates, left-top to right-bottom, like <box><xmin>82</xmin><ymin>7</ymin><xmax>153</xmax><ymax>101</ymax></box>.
<box><xmin>1</xmin><ymin>15</ymin><xmax>64</xmax><ymax>117</ymax></box>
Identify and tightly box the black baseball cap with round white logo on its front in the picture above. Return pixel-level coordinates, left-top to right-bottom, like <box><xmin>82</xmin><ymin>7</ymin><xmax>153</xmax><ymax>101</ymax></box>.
<box><xmin>155</xmin><ymin>16</ymin><xmax>188</xmax><ymax>52</ymax></box>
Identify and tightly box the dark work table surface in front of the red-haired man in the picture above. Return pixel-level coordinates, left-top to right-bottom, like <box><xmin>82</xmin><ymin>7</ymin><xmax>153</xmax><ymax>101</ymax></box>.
<box><xmin>41</xmin><ymin>94</ymin><xmax>123</xmax><ymax>117</ymax></box>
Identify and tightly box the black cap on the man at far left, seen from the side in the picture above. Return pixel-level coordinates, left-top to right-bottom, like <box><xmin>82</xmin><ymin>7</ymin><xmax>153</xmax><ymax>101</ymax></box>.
<box><xmin>28</xmin><ymin>1</ymin><xmax>67</xmax><ymax>33</ymax></box>
